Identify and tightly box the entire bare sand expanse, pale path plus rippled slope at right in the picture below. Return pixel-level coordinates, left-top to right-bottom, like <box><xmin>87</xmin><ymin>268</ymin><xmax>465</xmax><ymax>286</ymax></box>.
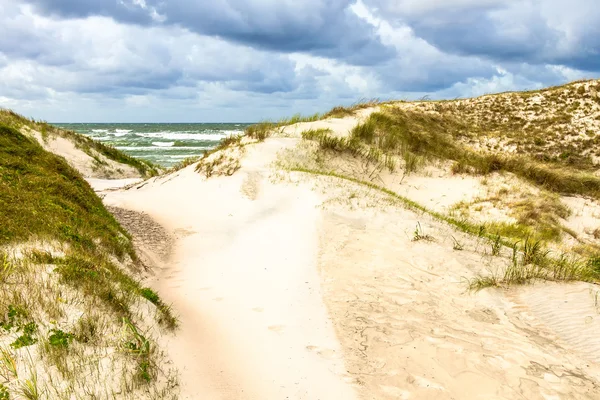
<box><xmin>96</xmin><ymin>118</ymin><xmax>600</xmax><ymax>400</ymax></box>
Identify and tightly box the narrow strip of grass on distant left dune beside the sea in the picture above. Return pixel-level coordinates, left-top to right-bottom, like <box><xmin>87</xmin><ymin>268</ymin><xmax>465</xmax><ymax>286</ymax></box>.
<box><xmin>0</xmin><ymin>109</ymin><xmax>159</xmax><ymax>177</ymax></box>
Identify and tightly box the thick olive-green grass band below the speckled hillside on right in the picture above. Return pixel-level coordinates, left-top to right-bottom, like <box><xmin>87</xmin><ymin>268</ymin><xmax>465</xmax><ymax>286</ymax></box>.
<box><xmin>350</xmin><ymin>108</ymin><xmax>600</xmax><ymax>197</ymax></box>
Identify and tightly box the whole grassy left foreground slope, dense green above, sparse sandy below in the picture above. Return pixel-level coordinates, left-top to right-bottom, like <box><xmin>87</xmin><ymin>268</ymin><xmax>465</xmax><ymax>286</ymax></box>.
<box><xmin>0</xmin><ymin>125</ymin><xmax>176</xmax><ymax>398</ymax></box>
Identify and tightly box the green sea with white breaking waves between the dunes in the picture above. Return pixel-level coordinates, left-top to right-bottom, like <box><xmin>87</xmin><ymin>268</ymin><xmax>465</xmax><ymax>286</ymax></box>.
<box><xmin>54</xmin><ymin>123</ymin><xmax>251</xmax><ymax>167</ymax></box>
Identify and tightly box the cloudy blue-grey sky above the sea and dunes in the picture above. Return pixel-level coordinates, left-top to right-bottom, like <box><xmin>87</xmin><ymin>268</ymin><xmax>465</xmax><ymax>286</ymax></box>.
<box><xmin>0</xmin><ymin>0</ymin><xmax>600</xmax><ymax>122</ymax></box>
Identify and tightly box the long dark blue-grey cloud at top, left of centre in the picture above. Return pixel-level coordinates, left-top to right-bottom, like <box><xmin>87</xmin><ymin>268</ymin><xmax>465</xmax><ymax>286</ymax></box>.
<box><xmin>23</xmin><ymin>0</ymin><xmax>394</xmax><ymax>65</ymax></box>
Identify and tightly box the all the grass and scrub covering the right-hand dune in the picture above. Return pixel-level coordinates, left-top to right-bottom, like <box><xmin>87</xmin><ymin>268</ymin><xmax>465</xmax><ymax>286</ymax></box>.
<box><xmin>292</xmin><ymin>81</ymin><xmax>600</xmax><ymax>288</ymax></box>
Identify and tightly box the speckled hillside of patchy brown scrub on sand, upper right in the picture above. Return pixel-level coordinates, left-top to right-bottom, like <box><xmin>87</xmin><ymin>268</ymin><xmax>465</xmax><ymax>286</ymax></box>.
<box><xmin>410</xmin><ymin>81</ymin><xmax>600</xmax><ymax>170</ymax></box>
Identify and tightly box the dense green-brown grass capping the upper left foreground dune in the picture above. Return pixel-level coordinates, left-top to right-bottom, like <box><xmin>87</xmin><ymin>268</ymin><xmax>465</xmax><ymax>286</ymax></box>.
<box><xmin>0</xmin><ymin>125</ymin><xmax>135</xmax><ymax>259</ymax></box>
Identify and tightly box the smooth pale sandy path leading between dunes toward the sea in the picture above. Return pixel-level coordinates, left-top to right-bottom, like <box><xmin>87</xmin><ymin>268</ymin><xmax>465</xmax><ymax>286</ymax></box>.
<box><xmin>104</xmin><ymin>140</ymin><xmax>355</xmax><ymax>400</ymax></box>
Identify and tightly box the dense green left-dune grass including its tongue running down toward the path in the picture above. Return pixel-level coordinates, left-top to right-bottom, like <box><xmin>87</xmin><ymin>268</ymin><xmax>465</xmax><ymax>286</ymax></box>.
<box><xmin>0</xmin><ymin>125</ymin><xmax>175</xmax><ymax>326</ymax></box>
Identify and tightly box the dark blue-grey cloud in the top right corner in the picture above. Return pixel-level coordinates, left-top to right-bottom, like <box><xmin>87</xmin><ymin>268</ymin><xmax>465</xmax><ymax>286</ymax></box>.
<box><xmin>365</xmin><ymin>0</ymin><xmax>600</xmax><ymax>71</ymax></box>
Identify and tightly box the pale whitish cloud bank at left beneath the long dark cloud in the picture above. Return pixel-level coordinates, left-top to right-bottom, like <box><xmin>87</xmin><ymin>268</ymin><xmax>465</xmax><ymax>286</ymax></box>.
<box><xmin>0</xmin><ymin>3</ymin><xmax>304</xmax><ymax>101</ymax></box>
